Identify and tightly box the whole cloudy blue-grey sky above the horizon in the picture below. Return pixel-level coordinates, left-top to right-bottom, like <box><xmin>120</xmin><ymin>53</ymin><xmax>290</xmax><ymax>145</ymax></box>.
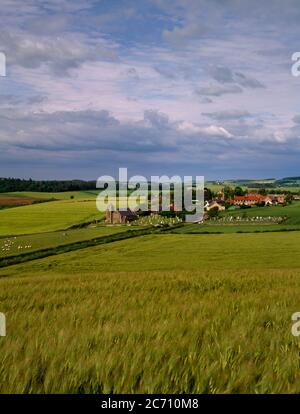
<box><xmin>0</xmin><ymin>0</ymin><xmax>300</xmax><ymax>180</ymax></box>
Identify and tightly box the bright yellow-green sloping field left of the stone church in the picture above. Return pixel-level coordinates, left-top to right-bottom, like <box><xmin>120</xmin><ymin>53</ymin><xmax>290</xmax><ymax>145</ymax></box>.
<box><xmin>0</xmin><ymin>200</ymin><xmax>103</xmax><ymax>236</ymax></box>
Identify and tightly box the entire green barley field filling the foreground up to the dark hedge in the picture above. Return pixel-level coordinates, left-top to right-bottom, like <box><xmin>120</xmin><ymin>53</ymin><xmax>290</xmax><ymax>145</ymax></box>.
<box><xmin>0</xmin><ymin>232</ymin><xmax>300</xmax><ymax>393</ymax></box>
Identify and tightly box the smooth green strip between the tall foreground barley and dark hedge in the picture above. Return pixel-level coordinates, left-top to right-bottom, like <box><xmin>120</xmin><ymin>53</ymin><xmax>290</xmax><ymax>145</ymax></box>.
<box><xmin>0</xmin><ymin>232</ymin><xmax>300</xmax><ymax>276</ymax></box>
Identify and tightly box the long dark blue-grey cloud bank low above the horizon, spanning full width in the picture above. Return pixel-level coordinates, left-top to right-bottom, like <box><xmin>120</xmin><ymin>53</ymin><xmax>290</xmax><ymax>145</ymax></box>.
<box><xmin>0</xmin><ymin>106</ymin><xmax>300</xmax><ymax>180</ymax></box>
